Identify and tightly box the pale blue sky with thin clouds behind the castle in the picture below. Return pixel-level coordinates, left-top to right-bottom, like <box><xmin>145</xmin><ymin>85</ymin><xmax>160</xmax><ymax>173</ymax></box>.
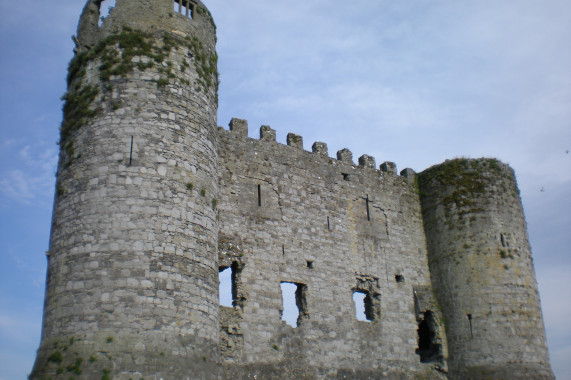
<box><xmin>0</xmin><ymin>0</ymin><xmax>571</xmax><ymax>380</ymax></box>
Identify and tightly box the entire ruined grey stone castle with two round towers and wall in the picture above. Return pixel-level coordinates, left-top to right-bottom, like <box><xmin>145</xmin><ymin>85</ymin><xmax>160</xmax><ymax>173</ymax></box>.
<box><xmin>31</xmin><ymin>0</ymin><xmax>554</xmax><ymax>380</ymax></box>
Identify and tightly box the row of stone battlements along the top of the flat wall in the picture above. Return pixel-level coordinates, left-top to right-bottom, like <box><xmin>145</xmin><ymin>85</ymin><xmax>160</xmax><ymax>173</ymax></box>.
<box><xmin>218</xmin><ymin>118</ymin><xmax>416</xmax><ymax>182</ymax></box>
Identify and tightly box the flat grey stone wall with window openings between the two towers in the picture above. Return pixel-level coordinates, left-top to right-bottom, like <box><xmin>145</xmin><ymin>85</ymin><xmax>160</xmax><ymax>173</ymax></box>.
<box><xmin>217</xmin><ymin>119</ymin><xmax>445</xmax><ymax>378</ymax></box>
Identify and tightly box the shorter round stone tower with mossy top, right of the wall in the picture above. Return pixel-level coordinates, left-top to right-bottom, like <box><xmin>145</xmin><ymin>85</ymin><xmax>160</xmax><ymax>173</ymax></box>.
<box><xmin>419</xmin><ymin>159</ymin><xmax>553</xmax><ymax>379</ymax></box>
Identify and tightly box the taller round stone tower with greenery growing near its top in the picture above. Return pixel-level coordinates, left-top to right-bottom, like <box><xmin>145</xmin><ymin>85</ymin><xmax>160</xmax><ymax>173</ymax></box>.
<box><xmin>31</xmin><ymin>0</ymin><xmax>218</xmax><ymax>379</ymax></box>
